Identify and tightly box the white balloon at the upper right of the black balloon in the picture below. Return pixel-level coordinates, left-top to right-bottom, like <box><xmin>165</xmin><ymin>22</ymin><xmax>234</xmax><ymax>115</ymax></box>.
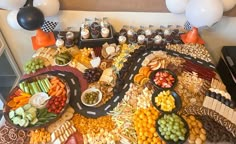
<box><xmin>33</xmin><ymin>0</ymin><xmax>60</xmax><ymax>17</ymax></box>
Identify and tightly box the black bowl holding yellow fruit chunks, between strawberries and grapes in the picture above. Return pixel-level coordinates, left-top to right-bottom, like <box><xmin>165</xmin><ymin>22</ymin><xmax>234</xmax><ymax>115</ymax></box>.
<box><xmin>152</xmin><ymin>90</ymin><xmax>182</xmax><ymax>113</ymax></box>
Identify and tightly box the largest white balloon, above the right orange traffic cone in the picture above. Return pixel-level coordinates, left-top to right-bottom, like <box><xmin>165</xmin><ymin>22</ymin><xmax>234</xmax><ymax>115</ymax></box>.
<box><xmin>185</xmin><ymin>0</ymin><xmax>223</xmax><ymax>27</ymax></box>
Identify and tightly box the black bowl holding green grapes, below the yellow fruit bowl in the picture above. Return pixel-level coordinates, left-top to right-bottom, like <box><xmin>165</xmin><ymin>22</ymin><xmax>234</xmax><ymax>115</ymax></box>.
<box><xmin>156</xmin><ymin>113</ymin><xmax>189</xmax><ymax>144</ymax></box>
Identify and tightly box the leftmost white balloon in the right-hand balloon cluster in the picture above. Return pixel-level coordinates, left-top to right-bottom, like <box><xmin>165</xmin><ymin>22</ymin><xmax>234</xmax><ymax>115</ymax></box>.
<box><xmin>166</xmin><ymin>0</ymin><xmax>189</xmax><ymax>14</ymax></box>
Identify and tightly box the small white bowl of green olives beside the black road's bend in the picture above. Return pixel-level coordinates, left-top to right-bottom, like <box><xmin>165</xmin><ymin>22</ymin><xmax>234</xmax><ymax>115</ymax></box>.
<box><xmin>81</xmin><ymin>88</ymin><xmax>102</xmax><ymax>107</ymax></box>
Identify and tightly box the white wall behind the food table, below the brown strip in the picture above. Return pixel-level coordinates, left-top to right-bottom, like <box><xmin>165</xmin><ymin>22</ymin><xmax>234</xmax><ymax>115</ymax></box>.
<box><xmin>0</xmin><ymin>10</ymin><xmax>236</xmax><ymax>70</ymax></box>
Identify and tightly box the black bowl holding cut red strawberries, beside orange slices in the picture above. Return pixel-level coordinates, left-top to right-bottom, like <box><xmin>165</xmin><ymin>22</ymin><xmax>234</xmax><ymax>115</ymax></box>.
<box><xmin>149</xmin><ymin>69</ymin><xmax>177</xmax><ymax>89</ymax></box>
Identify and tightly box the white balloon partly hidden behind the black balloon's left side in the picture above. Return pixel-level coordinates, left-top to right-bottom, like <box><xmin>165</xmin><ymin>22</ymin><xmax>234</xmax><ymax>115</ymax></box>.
<box><xmin>7</xmin><ymin>10</ymin><xmax>22</xmax><ymax>29</ymax></box>
